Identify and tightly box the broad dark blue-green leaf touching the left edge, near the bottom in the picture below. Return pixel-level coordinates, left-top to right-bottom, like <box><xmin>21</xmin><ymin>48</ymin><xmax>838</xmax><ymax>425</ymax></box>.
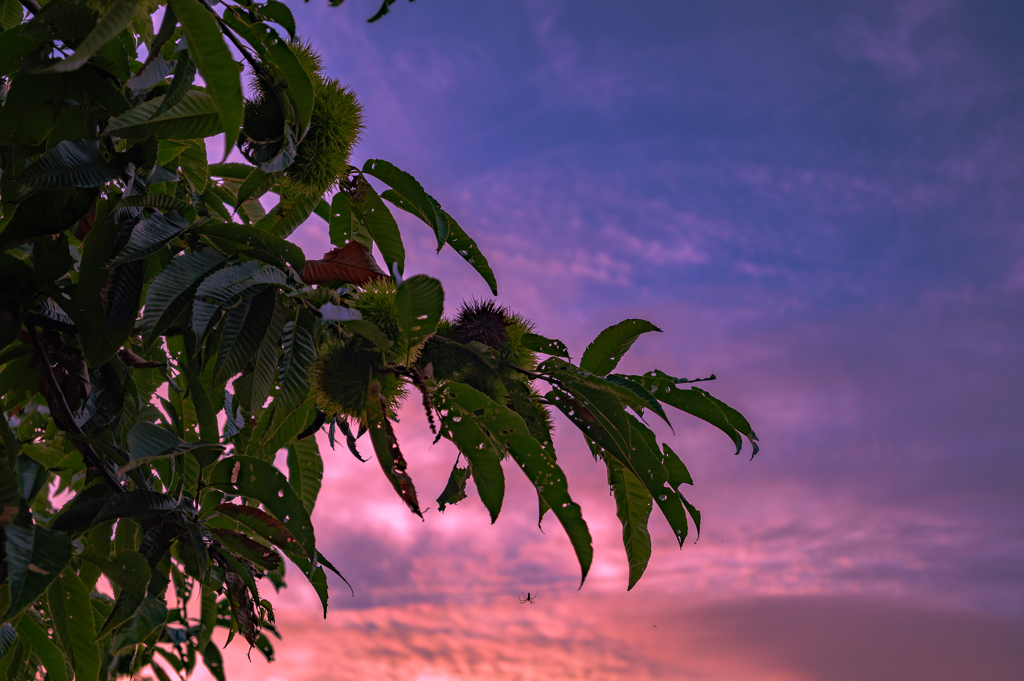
<box><xmin>4</xmin><ymin>525</ymin><xmax>73</xmax><ymax>619</ymax></box>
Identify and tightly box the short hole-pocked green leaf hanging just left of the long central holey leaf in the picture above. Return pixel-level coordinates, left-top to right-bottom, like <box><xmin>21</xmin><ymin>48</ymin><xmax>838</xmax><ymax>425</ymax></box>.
<box><xmin>436</xmin><ymin>393</ymin><xmax>505</xmax><ymax>523</ymax></box>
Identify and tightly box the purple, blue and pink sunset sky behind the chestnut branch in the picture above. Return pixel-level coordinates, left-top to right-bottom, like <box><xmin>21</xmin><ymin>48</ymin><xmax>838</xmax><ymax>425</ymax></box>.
<box><xmin>195</xmin><ymin>0</ymin><xmax>1024</xmax><ymax>681</ymax></box>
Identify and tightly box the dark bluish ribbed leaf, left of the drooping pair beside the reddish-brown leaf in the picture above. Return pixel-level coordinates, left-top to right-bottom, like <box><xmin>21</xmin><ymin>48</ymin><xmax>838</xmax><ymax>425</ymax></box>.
<box><xmin>140</xmin><ymin>246</ymin><xmax>224</xmax><ymax>347</ymax></box>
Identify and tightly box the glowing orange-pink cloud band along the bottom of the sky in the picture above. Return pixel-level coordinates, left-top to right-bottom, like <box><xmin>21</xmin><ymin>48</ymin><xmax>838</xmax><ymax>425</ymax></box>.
<box><xmin>194</xmin><ymin>592</ymin><xmax>1024</xmax><ymax>681</ymax></box>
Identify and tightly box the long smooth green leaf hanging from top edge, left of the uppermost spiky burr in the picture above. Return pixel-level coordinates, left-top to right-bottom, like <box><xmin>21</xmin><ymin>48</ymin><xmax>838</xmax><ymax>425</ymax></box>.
<box><xmin>168</xmin><ymin>0</ymin><xmax>245</xmax><ymax>159</ymax></box>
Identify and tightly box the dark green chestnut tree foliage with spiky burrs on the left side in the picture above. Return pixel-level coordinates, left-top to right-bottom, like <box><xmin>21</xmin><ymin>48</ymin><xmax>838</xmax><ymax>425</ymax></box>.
<box><xmin>0</xmin><ymin>0</ymin><xmax>757</xmax><ymax>681</ymax></box>
